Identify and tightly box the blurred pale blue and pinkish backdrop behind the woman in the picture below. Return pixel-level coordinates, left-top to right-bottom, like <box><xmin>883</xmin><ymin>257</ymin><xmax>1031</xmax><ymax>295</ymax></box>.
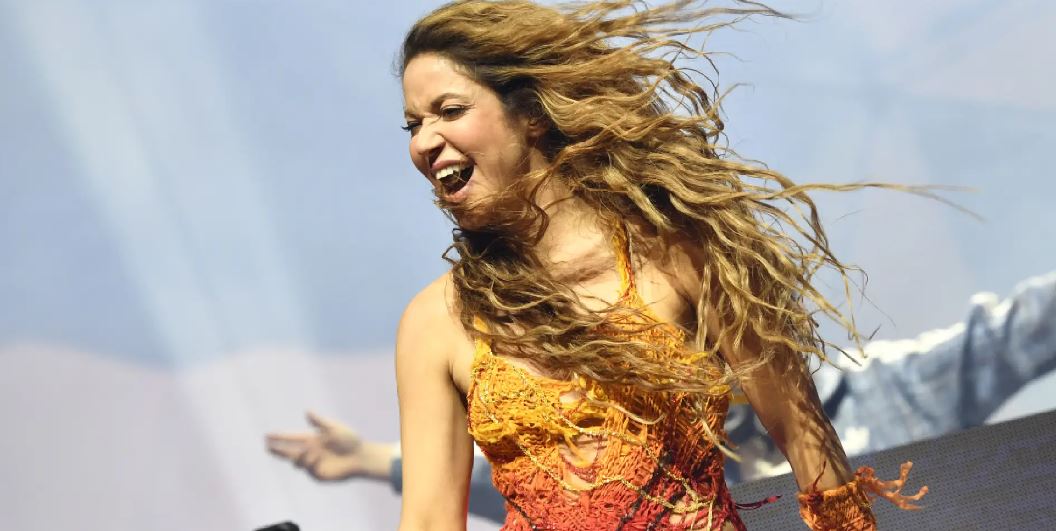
<box><xmin>0</xmin><ymin>0</ymin><xmax>1056</xmax><ymax>531</ymax></box>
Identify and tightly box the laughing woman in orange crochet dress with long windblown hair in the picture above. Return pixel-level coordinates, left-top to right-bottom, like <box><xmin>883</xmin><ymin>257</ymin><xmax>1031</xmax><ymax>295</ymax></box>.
<box><xmin>396</xmin><ymin>0</ymin><xmax>923</xmax><ymax>530</ymax></box>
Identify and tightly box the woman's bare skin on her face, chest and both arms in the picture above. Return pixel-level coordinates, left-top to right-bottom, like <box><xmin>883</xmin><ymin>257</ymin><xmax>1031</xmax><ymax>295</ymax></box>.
<box><xmin>396</xmin><ymin>54</ymin><xmax>851</xmax><ymax>531</ymax></box>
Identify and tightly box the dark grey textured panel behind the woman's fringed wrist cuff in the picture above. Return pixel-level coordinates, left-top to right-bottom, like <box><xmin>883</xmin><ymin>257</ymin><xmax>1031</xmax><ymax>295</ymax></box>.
<box><xmin>731</xmin><ymin>412</ymin><xmax>1056</xmax><ymax>531</ymax></box>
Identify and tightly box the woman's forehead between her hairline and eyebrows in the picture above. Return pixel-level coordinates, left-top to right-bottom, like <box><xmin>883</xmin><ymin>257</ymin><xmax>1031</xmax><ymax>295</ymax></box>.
<box><xmin>402</xmin><ymin>54</ymin><xmax>482</xmax><ymax>113</ymax></box>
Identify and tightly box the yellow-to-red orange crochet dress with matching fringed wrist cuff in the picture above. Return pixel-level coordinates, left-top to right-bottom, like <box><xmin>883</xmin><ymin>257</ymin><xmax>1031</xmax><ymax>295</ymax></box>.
<box><xmin>468</xmin><ymin>228</ymin><xmax>924</xmax><ymax>531</ymax></box>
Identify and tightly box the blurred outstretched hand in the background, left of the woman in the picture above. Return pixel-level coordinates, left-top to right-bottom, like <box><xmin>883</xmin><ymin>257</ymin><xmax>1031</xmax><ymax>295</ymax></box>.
<box><xmin>266</xmin><ymin>412</ymin><xmax>395</xmax><ymax>481</ymax></box>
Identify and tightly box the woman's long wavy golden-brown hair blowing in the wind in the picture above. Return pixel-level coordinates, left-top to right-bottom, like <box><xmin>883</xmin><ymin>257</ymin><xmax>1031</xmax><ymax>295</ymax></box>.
<box><xmin>400</xmin><ymin>0</ymin><xmax>912</xmax><ymax>396</ymax></box>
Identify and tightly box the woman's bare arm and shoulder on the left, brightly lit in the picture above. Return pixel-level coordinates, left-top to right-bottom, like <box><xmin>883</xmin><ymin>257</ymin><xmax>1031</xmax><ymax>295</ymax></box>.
<box><xmin>396</xmin><ymin>279</ymin><xmax>473</xmax><ymax>531</ymax></box>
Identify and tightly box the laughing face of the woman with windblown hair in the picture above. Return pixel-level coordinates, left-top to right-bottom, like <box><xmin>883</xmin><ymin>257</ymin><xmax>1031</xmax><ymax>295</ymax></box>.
<box><xmin>403</xmin><ymin>54</ymin><xmax>542</xmax><ymax>228</ymax></box>
